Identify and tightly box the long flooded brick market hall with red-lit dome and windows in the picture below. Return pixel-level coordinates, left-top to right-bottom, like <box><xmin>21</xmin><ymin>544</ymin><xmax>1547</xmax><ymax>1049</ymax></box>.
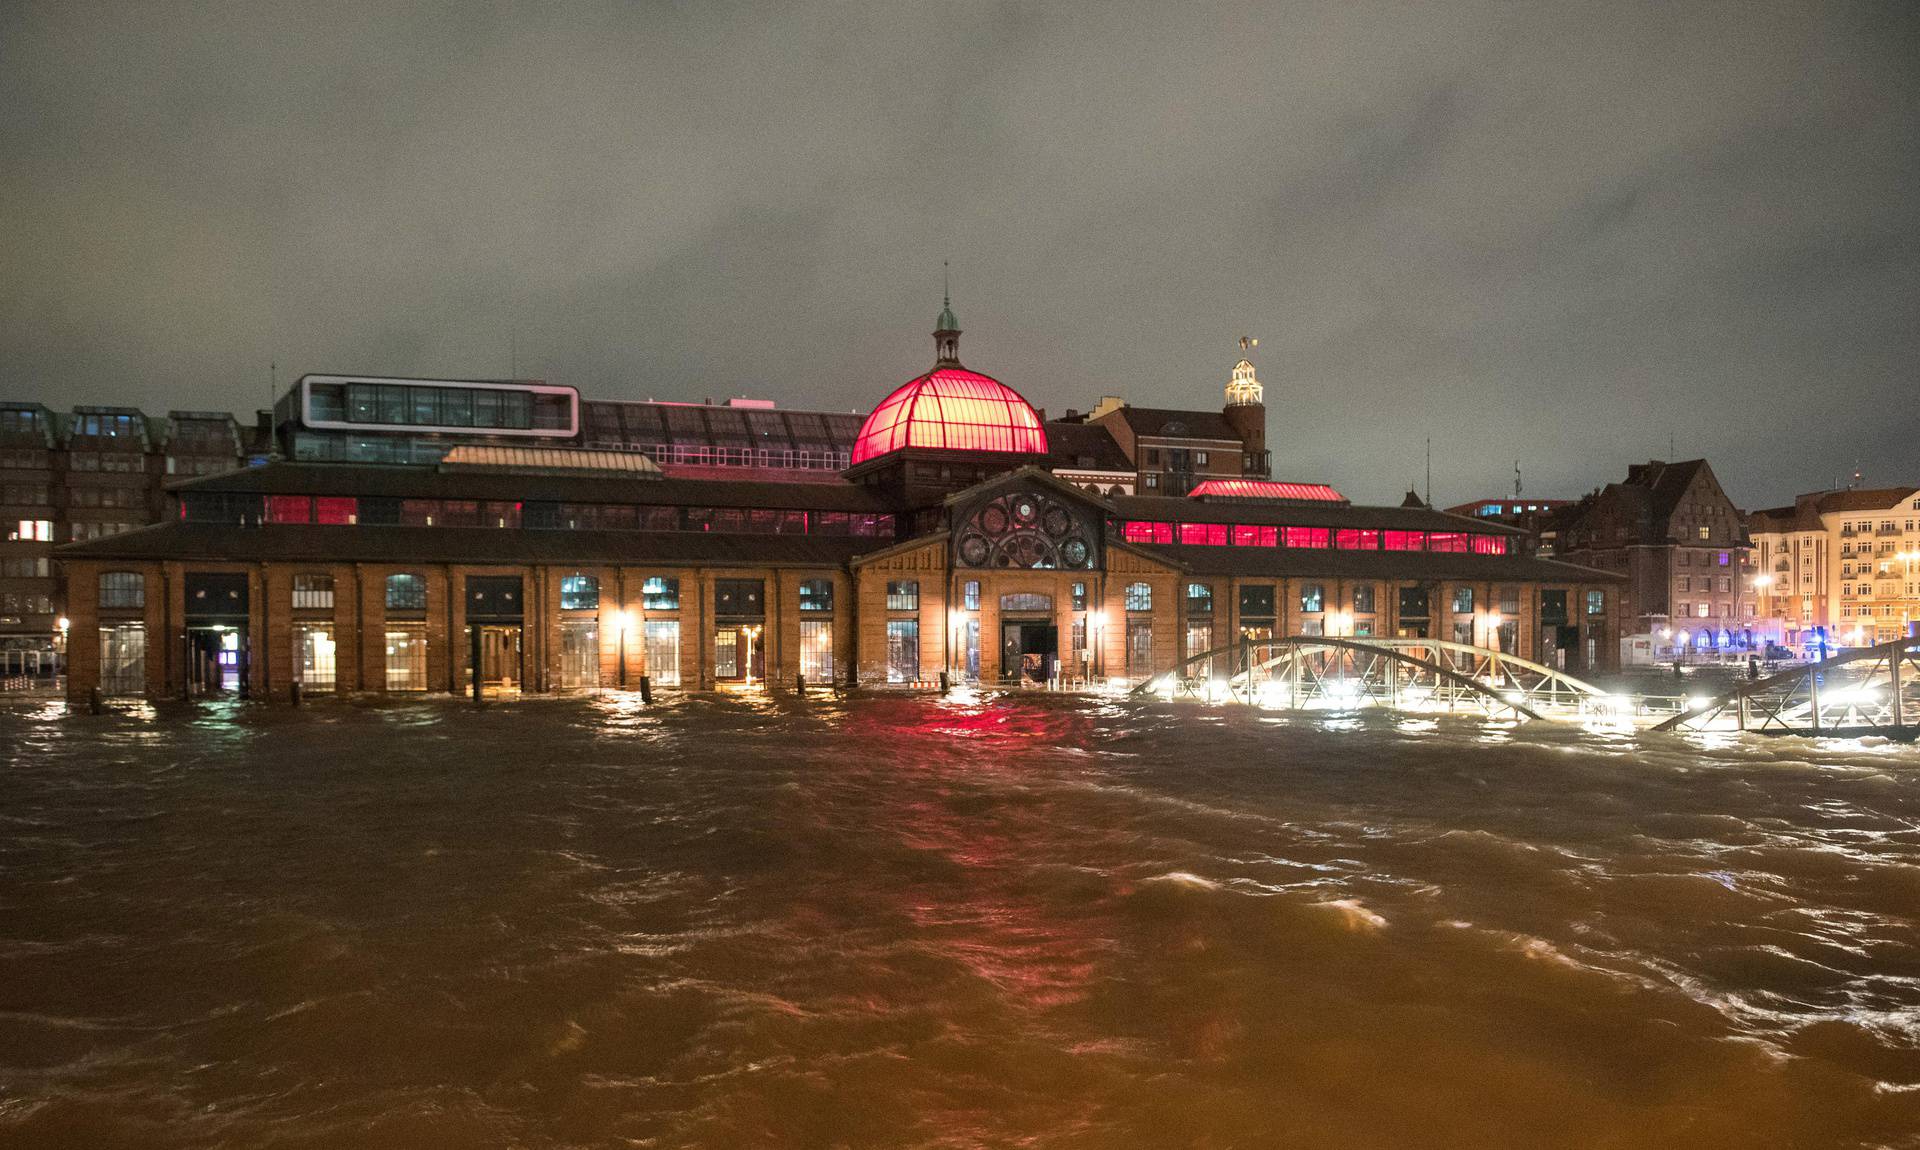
<box><xmin>58</xmin><ymin>309</ymin><xmax>1620</xmax><ymax>699</ymax></box>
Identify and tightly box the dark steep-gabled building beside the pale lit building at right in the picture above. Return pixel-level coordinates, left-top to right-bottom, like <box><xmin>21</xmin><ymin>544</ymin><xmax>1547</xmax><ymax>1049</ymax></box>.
<box><xmin>1551</xmin><ymin>459</ymin><xmax>1763</xmax><ymax>659</ymax></box>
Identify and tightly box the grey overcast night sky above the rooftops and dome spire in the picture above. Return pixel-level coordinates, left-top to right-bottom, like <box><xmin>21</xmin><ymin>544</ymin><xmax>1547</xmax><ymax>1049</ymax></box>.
<box><xmin>0</xmin><ymin>0</ymin><xmax>1920</xmax><ymax>507</ymax></box>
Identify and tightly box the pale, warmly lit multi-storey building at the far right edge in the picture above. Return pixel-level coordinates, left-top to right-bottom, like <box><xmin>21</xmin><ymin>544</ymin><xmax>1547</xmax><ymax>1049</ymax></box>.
<box><xmin>1747</xmin><ymin>486</ymin><xmax>1920</xmax><ymax>653</ymax></box>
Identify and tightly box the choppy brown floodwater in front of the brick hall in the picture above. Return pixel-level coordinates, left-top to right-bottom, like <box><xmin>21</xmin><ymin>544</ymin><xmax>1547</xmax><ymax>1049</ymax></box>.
<box><xmin>0</xmin><ymin>697</ymin><xmax>1920</xmax><ymax>1150</ymax></box>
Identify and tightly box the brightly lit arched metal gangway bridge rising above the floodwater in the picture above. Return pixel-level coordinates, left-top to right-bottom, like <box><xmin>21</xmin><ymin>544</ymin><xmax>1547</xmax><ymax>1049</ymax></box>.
<box><xmin>1133</xmin><ymin>635</ymin><xmax>1920</xmax><ymax>739</ymax></box>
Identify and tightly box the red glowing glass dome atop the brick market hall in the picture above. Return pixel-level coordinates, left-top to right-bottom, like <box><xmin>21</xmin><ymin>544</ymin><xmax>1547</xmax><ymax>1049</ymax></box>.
<box><xmin>852</xmin><ymin>365</ymin><xmax>1046</xmax><ymax>465</ymax></box>
